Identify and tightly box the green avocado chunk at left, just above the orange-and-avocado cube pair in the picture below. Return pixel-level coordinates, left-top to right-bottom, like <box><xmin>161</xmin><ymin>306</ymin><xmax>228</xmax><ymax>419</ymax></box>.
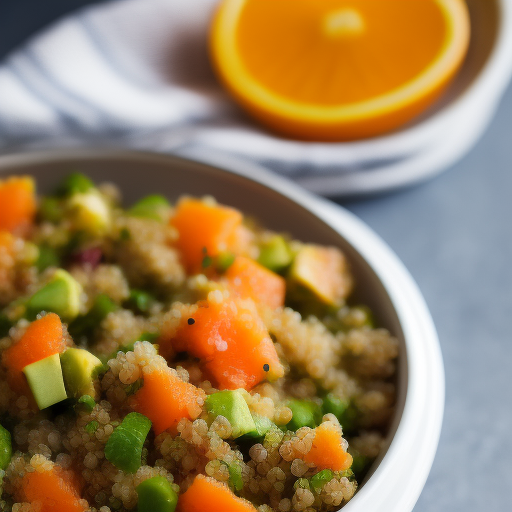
<box><xmin>25</xmin><ymin>268</ymin><xmax>82</xmax><ymax>320</ymax></box>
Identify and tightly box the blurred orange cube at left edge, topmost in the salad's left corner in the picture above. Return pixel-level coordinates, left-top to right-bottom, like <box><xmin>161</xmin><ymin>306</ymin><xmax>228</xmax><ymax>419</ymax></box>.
<box><xmin>0</xmin><ymin>177</ymin><xmax>36</xmax><ymax>231</ymax></box>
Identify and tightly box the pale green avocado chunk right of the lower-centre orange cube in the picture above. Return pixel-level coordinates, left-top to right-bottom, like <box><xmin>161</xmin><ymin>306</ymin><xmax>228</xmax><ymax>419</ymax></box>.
<box><xmin>205</xmin><ymin>390</ymin><xmax>256</xmax><ymax>439</ymax></box>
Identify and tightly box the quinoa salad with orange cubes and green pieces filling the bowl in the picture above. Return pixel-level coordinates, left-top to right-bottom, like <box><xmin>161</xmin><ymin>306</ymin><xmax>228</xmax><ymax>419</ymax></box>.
<box><xmin>0</xmin><ymin>173</ymin><xmax>398</xmax><ymax>512</ymax></box>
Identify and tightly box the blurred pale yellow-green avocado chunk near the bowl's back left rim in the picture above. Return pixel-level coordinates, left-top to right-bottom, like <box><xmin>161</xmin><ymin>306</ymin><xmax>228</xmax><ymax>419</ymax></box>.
<box><xmin>68</xmin><ymin>190</ymin><xmax>112</xmax><ymax>236</ymax></box>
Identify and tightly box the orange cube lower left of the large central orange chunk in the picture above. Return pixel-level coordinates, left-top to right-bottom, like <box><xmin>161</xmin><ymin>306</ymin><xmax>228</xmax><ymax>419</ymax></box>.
<box><xmin>131</xmin><ymin>367</ymin><xmax>206</xmax><ymax>435</ymax></box>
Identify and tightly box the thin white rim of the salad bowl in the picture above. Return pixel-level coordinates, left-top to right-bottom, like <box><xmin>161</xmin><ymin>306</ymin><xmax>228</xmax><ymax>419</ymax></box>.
<box><xmin>0</xmin><ymin>149</ymin><xmax>445</xmax><ymax>512</ymax></box>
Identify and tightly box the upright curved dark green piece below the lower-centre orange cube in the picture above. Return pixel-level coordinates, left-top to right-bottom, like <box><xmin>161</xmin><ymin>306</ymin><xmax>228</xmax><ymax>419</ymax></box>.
<box><xmin>105</xmin><ymin>412</ymin><xmax>151</xmax><ymax>473</ymax></box>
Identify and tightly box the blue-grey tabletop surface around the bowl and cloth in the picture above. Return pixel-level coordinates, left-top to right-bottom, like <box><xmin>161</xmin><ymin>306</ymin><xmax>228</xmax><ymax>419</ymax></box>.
<box><xmin>0</xmin><ymin>0</ymin><xmax>512</xmax><ymax>512</ymax></box>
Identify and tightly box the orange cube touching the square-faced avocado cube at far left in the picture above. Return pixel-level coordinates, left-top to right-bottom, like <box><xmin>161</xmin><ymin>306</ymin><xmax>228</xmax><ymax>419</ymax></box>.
<box><xmin>2</xmin><ymin>313</ymin><xmax>66</xmax><ymax>393</ymax></box>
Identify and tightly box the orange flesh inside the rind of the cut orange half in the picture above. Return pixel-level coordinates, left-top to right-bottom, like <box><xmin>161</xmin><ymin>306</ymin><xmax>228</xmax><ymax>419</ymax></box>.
<box><xmin>236</xmin><ymin>0</ymin><xmax>447</xmax><ymax>106</ymax></box>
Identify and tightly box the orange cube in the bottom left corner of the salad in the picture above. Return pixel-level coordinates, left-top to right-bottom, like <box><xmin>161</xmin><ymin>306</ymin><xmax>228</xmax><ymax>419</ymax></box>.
<box><xmin>21</xmin><ymin>466</ymin><xmax>87</xmax><ymax>512</ymax></box>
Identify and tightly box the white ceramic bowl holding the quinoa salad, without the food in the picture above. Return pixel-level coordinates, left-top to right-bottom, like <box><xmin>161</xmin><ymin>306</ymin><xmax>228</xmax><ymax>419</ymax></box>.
<box><xmin>0</xmin><ymin>151</ymin><xmax>444</xmax><ymax>512</ymax></box>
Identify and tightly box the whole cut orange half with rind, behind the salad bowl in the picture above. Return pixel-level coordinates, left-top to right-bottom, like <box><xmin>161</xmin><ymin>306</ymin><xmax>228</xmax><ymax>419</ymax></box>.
<box><xmin>210</xmin><ymin>0</ymin><xmax>470</xmax><ymax>140</ymax></box>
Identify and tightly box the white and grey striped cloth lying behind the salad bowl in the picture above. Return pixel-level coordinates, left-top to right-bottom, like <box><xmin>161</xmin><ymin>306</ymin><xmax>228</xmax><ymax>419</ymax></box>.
<box><xmin>0</xmin><ymin>0</ymin><xmax>510</xmax><ymax>194</ymax></box>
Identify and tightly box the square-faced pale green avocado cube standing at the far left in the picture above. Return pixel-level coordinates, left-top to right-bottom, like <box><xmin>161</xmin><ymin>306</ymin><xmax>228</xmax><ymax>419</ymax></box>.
<box><xmin>23</xmin><ymin>354</ymin><xmax>67</xmax><ymax>410</ymax></box>
